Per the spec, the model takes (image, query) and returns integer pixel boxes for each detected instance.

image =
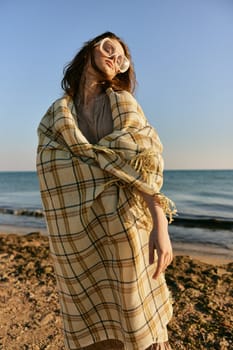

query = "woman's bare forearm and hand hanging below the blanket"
[138,192,173,279]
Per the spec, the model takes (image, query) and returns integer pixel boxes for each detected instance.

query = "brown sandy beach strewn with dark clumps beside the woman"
[0,226,233,350]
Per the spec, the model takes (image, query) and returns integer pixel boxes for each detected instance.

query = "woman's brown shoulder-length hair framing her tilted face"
[61,32,136,97]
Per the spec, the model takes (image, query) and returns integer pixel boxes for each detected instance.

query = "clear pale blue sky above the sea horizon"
[0,0,233,170]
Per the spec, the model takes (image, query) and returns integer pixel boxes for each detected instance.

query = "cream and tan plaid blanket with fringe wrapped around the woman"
[37,88,173,350]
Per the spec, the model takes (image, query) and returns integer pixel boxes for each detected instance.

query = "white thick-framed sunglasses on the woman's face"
[95,38,130,73]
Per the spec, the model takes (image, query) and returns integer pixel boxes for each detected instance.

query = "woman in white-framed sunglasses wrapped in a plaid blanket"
[37,32,175,350]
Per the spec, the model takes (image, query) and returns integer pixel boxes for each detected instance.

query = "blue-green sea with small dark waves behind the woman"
[0,170,233,251]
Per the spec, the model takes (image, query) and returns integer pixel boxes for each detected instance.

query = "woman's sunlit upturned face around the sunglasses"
[94,39,125,80]
